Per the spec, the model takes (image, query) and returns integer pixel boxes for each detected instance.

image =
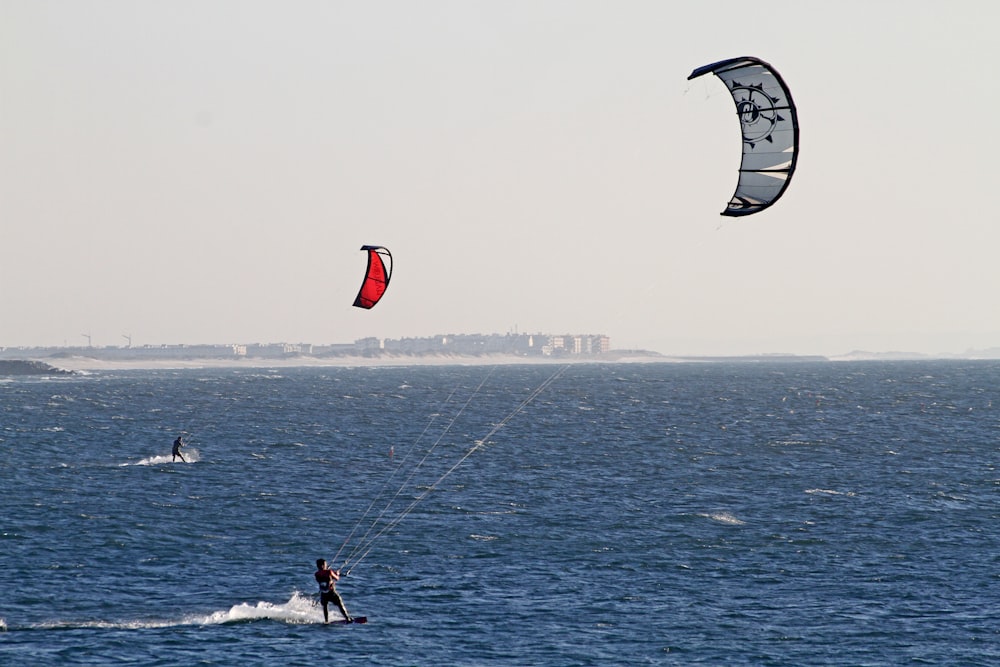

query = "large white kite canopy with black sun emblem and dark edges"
[688,57,799,216]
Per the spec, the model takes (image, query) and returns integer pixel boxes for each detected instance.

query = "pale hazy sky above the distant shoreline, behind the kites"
[0,0,1000,354]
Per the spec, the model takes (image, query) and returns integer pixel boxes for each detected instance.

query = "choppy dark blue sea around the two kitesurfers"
[0,360,1000,667]
